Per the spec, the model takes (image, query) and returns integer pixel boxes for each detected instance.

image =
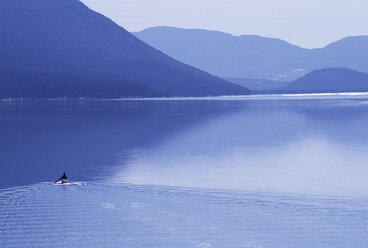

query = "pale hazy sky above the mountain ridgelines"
[82,0,368,48]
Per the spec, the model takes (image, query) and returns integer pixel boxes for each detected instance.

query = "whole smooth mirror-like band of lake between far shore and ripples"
[0,96,368,196]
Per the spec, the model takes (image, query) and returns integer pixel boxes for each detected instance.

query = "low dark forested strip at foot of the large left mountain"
[0,71,160,99]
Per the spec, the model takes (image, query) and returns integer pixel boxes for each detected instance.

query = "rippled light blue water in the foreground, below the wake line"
[0,183,368,248]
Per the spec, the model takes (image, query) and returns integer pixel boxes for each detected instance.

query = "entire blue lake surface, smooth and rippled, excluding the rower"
[0,95,368,247]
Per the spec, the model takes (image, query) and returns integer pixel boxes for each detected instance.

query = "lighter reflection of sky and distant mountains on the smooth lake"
[114,100,368,196]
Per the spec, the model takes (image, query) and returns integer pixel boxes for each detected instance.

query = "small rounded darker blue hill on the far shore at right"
[278,68,368,93]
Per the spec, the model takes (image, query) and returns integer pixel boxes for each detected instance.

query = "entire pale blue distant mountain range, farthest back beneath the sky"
[133,27,368,81]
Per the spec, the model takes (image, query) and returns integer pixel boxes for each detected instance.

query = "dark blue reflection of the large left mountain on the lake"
[0,101,244,188]
